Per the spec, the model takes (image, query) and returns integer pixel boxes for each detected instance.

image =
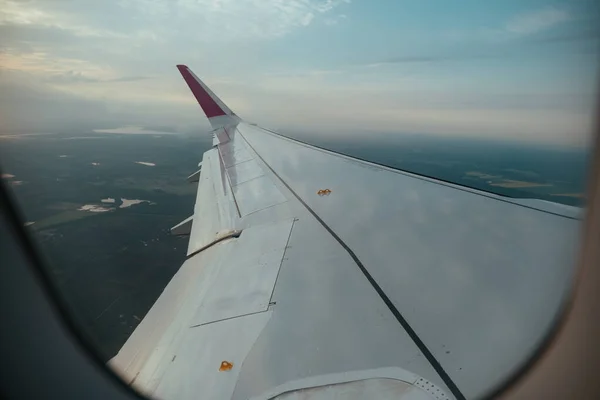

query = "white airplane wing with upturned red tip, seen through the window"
[110,65,580,400]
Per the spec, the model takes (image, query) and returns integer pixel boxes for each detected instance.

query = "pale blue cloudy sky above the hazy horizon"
[0,0,600,146]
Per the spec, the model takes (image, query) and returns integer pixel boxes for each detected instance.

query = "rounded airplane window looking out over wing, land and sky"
[0,0,600,400]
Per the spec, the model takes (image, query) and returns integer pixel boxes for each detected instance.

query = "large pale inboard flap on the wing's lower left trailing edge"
[110,220,293,398]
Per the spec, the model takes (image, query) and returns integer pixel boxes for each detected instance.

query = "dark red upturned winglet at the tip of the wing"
[177,64,239,128]
